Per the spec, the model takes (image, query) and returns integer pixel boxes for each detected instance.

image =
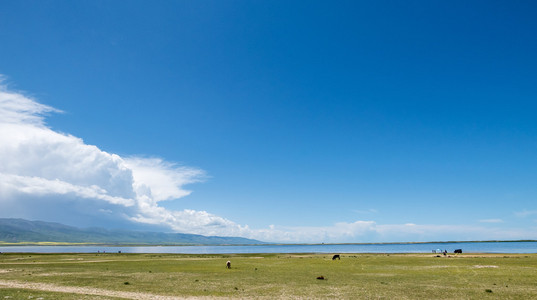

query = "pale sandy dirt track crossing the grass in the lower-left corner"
[0,280,220,300]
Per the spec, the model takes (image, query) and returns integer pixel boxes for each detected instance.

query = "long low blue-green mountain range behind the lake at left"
[0,218,264,245]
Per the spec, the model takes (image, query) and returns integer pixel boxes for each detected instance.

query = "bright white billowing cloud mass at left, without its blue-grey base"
[0,82,213,233]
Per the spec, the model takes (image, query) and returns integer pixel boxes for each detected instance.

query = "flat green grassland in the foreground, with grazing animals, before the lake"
[0,253,537,299]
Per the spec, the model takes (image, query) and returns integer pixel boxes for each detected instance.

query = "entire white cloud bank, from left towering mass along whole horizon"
[0,81,537,242]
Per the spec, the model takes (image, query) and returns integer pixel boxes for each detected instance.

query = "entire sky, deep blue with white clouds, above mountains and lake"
[0,0,537,242]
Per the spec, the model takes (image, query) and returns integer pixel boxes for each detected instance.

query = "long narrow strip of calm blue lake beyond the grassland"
[0,242,537,254]
